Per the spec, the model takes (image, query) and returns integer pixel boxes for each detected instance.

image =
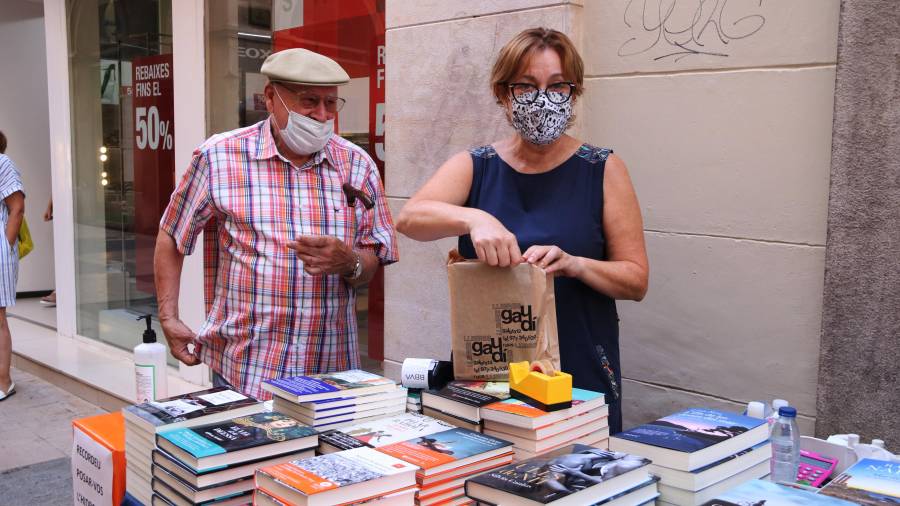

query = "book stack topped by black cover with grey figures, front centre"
[465,445,659,506]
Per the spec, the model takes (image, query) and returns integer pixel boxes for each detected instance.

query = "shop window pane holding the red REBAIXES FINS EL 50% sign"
[67,0,175,364]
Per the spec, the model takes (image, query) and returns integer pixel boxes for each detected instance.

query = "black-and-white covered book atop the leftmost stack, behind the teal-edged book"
[122,387,265,431]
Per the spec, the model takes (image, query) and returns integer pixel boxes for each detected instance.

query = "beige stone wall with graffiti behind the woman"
[385,0,840,433]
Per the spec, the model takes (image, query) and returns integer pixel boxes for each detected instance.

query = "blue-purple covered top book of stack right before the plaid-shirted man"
[262,369,397,403]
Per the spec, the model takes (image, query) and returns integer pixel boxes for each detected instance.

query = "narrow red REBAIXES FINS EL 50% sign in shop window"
[131,54,175,293]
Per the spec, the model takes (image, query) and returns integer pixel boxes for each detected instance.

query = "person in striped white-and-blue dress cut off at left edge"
[0,132,25,401]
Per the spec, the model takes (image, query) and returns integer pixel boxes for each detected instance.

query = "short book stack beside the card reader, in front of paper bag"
[422,381,509,432]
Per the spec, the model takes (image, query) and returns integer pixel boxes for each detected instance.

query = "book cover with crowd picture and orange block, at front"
[257,448,415,495]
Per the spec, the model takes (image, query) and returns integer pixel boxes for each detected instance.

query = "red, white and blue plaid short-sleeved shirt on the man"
[160,120,398,399]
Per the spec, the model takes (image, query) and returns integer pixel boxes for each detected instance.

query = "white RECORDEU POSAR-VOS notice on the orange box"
[72,428,113,506]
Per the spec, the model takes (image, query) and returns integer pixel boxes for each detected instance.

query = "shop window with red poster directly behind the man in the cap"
[206,0,384,370]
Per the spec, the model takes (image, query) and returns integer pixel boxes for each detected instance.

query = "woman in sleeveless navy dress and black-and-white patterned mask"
[397,28,649,433]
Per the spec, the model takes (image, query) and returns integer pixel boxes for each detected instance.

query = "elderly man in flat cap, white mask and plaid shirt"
[154,49,398,399]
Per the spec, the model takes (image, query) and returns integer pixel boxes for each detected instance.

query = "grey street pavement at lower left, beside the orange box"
[0,368,105,506]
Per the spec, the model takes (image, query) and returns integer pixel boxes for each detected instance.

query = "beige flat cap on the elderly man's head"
[260,48,350,86]
